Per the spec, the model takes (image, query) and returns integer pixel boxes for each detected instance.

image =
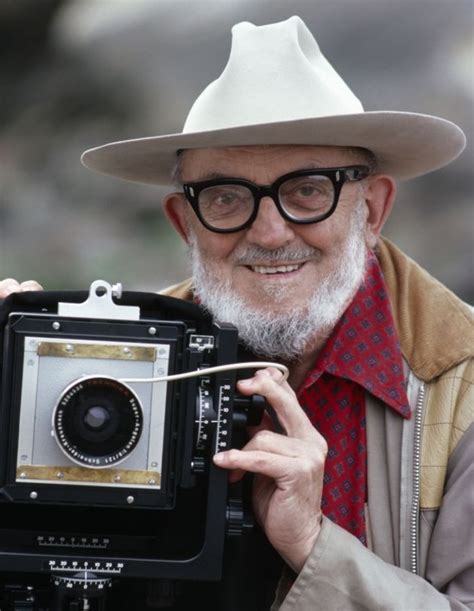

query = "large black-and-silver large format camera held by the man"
[0,281,274,611]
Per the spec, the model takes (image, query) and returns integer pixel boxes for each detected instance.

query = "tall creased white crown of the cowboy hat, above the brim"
[183,16,363,133]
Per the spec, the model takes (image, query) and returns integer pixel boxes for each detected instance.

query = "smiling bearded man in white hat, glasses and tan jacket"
[0,17,474,611]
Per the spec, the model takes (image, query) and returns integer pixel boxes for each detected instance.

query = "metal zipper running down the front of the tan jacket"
[410,383,425,575]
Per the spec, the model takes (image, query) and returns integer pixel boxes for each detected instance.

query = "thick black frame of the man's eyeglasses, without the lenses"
[182,165,370,233]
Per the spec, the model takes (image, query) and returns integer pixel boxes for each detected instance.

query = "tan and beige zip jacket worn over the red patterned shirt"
[161,240,474,611]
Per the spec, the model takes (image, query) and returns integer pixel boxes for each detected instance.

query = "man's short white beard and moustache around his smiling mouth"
[190,205,366,362]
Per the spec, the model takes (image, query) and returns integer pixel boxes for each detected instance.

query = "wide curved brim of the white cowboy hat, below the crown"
[81,111,466,185]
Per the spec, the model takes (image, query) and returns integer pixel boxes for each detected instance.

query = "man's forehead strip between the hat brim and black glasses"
[180,145,362,180]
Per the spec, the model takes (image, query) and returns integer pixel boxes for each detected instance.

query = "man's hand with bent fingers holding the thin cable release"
[214,368,327,572]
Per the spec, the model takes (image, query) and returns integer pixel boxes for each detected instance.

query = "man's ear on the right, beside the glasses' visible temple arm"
[364,174,397,248]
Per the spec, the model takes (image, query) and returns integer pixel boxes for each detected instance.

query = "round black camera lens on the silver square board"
[53,376,143,468]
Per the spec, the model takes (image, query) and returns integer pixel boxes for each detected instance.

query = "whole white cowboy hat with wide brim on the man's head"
[82,16,466,185]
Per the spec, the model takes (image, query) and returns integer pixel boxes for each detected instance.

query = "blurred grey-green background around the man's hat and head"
[0,0,474,303]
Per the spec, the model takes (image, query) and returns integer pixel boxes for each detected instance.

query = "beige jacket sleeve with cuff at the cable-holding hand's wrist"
[272,426,474,611]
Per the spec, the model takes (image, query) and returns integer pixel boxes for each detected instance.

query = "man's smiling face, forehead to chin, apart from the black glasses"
[178,146,370,312]
